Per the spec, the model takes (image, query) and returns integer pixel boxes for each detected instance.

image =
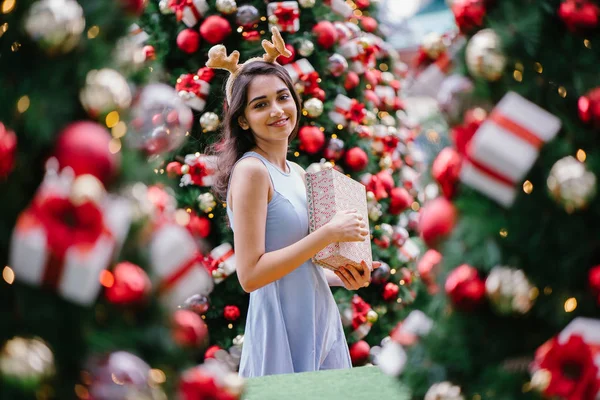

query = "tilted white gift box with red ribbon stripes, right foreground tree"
[460,92,561,207]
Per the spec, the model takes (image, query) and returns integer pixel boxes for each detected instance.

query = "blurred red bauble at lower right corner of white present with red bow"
[105,261,151,305]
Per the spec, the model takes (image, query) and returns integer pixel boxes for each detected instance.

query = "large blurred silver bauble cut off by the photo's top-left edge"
[25,0,85,54]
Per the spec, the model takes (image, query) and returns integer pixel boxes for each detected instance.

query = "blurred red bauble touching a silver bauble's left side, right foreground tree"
[445,264,485,311]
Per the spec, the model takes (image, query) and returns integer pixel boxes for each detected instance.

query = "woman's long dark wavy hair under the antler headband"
[207,61,302,201]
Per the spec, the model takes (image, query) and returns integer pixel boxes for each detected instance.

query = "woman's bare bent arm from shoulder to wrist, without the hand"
[230,157,335,293]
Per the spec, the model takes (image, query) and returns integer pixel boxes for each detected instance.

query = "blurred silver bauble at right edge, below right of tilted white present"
[547,156,596,212]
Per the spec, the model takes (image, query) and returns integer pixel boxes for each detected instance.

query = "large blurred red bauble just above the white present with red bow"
[53,121,121,186]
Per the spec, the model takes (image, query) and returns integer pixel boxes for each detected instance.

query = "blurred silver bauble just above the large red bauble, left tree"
[79,68,131,118]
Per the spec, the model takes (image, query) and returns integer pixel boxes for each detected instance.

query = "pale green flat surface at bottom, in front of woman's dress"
[242,367,410,400]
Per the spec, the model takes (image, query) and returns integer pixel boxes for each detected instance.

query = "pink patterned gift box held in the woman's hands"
[306,168,373,271]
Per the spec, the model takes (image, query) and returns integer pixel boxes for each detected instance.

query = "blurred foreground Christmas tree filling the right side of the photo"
[390,0,600,400]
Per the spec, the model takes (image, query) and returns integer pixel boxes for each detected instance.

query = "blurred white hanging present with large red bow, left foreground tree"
[9,158,131,306]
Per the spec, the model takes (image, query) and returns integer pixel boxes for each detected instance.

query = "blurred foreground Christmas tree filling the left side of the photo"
[0,0,242,400]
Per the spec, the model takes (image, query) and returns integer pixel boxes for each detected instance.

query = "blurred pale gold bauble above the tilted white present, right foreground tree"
[465,29,506,81]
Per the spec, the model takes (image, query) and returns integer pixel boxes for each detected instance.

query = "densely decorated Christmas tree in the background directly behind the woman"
[140,0,434,365]
